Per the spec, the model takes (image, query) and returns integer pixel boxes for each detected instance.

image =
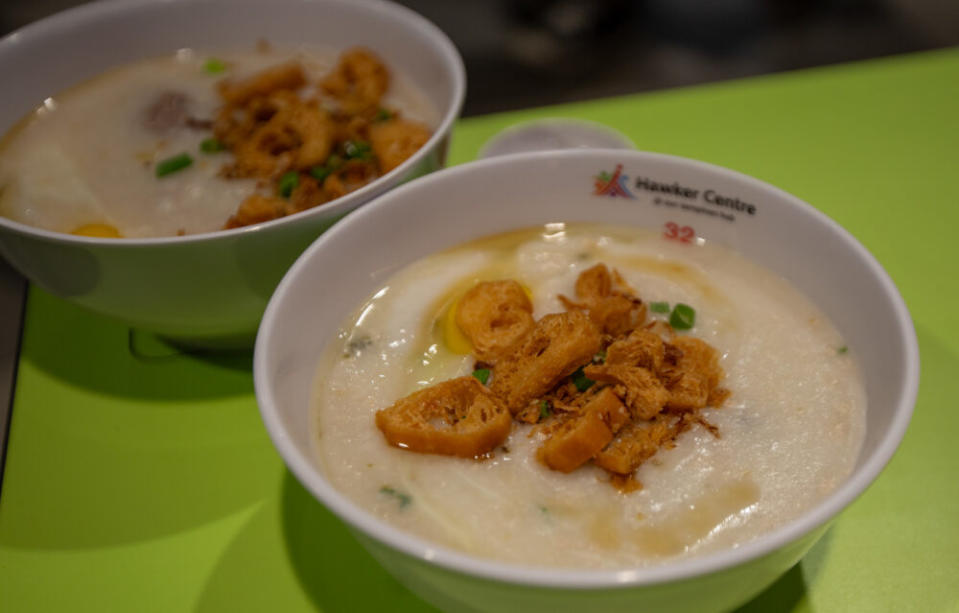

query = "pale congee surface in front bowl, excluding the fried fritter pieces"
[313,224,866,568]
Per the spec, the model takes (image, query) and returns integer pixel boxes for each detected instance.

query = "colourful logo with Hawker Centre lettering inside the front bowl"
[593,164,756,221]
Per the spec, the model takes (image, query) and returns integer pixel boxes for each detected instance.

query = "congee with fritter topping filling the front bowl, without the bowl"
[312,224,866,568]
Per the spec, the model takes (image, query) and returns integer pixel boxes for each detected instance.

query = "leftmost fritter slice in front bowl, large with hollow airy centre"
[376,376,513,458]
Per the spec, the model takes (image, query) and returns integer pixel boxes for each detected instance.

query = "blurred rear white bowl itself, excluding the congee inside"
[0,0,466,345]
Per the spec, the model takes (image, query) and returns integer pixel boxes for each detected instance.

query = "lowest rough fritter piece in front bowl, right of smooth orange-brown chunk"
[593,414,689,475]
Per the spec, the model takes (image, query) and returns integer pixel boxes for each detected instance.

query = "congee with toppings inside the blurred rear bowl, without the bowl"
[0,43,438,237]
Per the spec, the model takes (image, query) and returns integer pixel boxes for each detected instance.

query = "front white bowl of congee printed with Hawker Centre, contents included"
[254,150,919,612]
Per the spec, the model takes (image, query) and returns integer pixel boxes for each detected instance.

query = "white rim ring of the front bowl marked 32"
[253,149,919,590]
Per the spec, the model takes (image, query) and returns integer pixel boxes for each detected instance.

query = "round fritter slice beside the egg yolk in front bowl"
[456,280,536,364]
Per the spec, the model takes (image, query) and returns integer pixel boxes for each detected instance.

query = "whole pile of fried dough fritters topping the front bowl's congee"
[376,264,730,491]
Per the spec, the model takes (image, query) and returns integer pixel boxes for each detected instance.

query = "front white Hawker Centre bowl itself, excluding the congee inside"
[254,150,919,613]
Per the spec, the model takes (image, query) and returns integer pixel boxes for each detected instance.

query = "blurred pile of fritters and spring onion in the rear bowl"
[210,48,431,228]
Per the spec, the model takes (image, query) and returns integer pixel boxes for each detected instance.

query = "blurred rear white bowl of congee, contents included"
[0,0,465,346]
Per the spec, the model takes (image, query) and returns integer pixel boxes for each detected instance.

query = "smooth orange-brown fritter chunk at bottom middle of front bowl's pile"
[537,387,630,473]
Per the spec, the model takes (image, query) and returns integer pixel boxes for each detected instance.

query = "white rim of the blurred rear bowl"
[0,0,466,248]
